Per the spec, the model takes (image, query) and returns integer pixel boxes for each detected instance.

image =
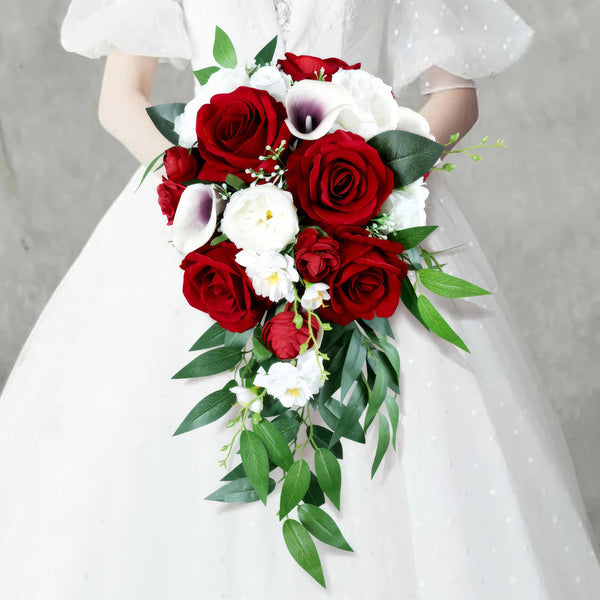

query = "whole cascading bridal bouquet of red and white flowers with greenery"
[146,28,501,586]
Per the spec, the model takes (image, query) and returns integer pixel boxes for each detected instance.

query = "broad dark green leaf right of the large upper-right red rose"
[368,130,444,187]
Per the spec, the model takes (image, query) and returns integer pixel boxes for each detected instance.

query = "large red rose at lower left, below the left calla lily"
[181,242,270,333]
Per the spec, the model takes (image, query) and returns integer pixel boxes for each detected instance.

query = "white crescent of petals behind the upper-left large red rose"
[174,66,250,148]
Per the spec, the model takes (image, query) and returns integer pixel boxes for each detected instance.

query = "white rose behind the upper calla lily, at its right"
[331,69,399,139]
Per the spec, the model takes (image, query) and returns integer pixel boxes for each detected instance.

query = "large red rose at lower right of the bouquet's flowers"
[319,227,408,325]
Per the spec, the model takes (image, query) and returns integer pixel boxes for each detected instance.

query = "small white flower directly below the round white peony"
[235,250,300,302]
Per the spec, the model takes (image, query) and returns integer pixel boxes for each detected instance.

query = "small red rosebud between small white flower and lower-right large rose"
[294,227,340,283]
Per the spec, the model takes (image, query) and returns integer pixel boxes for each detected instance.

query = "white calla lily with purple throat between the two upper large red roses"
[286,79,358,140]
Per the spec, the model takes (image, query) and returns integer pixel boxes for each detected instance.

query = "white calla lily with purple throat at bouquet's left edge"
[173,183,219,254]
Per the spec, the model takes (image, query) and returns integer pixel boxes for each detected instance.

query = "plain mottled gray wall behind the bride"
[0,0,600,532]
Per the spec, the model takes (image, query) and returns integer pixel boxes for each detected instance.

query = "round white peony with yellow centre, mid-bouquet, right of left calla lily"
[221,183,299,252]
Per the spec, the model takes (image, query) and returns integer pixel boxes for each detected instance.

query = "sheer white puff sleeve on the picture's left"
[61,0,191,68]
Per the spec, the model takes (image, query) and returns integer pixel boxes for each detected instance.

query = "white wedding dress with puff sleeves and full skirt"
[0,0,600,600]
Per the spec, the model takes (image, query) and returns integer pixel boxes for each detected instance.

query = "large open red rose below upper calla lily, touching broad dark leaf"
[287,131,394,226]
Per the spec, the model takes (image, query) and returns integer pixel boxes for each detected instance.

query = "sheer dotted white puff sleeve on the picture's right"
[388,0,533,93]
